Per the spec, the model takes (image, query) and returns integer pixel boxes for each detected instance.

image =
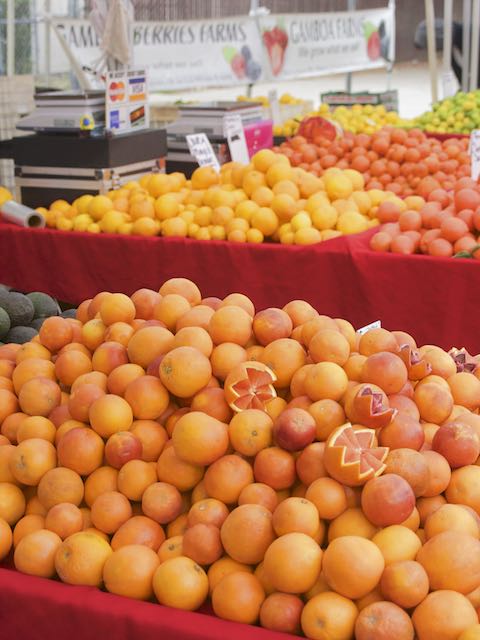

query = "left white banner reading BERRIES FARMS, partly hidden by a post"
[51,16,265,90]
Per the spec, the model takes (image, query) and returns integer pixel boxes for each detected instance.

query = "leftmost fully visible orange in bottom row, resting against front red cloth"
[13,529,62,578]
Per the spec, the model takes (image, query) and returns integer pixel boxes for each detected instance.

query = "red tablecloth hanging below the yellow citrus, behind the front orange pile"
[0,224,480,353]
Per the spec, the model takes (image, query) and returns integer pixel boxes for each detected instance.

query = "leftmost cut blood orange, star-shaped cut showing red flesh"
[223,361,277,411]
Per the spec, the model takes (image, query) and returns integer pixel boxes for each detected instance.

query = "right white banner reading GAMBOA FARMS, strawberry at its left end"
[260,9,395,79]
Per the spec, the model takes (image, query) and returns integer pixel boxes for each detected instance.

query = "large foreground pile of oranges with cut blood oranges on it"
[0,278,480,640]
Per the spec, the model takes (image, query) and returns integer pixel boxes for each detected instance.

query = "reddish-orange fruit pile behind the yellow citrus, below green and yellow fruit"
[275,127,470,197]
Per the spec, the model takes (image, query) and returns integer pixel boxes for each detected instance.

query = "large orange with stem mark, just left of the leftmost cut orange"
[160,347,212,398]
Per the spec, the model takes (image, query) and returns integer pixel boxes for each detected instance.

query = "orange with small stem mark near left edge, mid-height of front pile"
[9,440,57,486]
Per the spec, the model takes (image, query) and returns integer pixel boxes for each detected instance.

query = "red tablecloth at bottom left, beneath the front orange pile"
[0,568,298,640]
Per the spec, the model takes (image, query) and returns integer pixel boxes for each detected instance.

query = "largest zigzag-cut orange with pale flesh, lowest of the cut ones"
[323,422,389,487]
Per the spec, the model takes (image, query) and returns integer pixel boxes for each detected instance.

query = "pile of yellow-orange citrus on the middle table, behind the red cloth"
[38,149,407,245]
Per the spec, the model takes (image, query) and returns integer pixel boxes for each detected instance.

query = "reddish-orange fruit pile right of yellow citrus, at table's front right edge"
[370,177,480,260]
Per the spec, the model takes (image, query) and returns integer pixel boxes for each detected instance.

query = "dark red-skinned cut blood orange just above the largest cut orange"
[345,384,397,429]
